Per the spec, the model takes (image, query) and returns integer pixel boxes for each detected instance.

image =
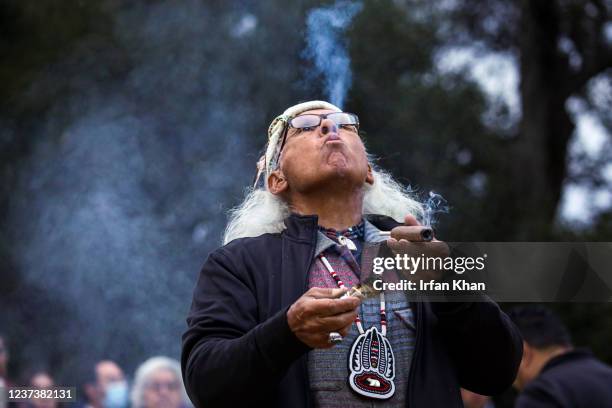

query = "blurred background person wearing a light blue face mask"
[83,360,129,408]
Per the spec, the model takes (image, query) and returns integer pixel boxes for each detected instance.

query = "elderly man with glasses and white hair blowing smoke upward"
[182,101,522,408]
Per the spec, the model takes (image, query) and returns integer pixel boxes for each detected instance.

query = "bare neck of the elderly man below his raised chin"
[291,190,363,230]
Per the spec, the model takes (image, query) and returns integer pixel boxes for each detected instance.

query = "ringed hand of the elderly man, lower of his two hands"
[287,288,361,348]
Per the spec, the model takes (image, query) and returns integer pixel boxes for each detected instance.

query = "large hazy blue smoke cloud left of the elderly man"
[0,0,301,384]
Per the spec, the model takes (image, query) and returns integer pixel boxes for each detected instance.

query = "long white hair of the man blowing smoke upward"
[223,160,424,244]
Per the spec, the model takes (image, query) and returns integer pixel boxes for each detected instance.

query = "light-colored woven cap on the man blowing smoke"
[253,101,342,189]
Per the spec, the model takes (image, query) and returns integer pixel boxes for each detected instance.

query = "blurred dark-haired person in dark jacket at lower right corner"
[509,305,612,408]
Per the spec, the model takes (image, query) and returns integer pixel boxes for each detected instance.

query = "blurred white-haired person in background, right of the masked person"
[131,357,191,408]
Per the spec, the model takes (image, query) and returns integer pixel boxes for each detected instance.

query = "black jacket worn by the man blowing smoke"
[181,214,522,408]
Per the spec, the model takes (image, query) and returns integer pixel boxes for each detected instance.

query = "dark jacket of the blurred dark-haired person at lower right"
[515,350,612,408]
